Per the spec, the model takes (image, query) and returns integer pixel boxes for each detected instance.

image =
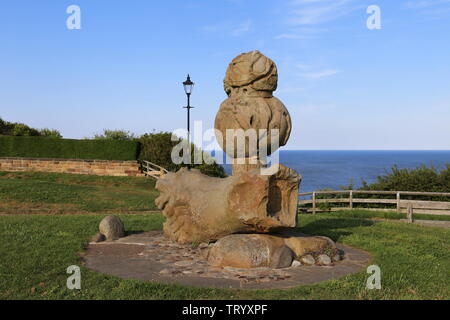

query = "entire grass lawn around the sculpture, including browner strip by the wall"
[0,172,450,299]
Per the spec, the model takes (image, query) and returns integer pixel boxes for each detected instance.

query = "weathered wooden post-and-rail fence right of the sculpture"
[298,190,450,215]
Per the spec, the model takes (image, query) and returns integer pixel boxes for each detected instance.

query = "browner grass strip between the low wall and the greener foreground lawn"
[0,172,158,214]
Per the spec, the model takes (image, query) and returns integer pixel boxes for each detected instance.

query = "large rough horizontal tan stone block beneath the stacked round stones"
[155,165,301,243]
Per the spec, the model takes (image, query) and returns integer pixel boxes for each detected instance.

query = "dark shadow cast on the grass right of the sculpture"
[297,218,376,241]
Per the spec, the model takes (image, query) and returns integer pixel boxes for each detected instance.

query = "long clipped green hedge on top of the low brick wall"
[0,136,140,160]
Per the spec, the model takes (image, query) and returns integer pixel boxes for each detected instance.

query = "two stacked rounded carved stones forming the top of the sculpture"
[215,51,292,158]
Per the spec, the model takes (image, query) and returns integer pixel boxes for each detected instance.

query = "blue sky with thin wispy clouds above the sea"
[0,0,450,150]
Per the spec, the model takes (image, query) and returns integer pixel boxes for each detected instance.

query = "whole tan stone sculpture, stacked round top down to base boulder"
[156,51,336,268]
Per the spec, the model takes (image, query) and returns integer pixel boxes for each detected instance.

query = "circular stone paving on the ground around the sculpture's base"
[84,231,370,289]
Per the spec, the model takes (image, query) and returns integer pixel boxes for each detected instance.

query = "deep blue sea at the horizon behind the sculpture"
[223,150,450,192]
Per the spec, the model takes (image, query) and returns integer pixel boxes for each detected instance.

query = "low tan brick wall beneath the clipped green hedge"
[0,158,143,177]
